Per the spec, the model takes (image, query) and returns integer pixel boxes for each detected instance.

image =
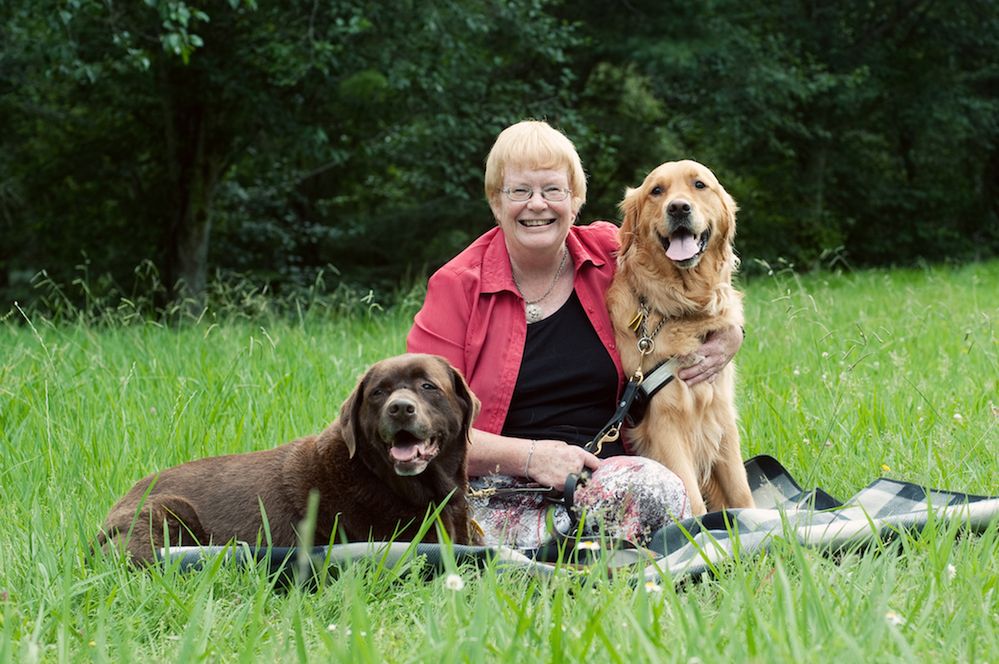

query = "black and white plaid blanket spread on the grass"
[161,455,999,580]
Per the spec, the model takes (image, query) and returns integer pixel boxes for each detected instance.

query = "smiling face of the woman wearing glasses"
[490,168,576,259]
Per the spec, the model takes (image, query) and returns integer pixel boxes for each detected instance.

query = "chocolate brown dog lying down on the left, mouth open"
[98,355,479,562]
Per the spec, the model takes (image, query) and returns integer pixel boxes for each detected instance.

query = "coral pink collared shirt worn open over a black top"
[406,221,624,434]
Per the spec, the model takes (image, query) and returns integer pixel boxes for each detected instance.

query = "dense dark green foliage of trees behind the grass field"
[0,0,999,306]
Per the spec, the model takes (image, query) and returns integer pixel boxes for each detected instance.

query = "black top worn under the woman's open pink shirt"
[503,291,624,456]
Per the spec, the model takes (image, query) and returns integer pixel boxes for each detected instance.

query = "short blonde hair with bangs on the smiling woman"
[485,120,586,212]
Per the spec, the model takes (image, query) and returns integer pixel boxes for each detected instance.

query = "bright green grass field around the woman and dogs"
[0,262,999,662]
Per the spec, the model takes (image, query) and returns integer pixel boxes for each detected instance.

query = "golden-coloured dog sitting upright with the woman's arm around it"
[607,161,753,515]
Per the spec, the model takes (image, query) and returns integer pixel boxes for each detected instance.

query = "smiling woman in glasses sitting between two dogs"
[407,121,742,547]
